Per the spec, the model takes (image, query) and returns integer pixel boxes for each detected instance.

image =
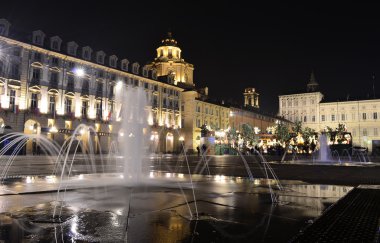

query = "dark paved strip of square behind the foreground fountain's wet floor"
[0,155,380,186]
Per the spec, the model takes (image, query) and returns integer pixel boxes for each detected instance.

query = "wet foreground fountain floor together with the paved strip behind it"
[0,156,380,243]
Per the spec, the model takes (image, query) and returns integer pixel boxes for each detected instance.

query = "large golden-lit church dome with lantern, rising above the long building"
[147,32,194,86]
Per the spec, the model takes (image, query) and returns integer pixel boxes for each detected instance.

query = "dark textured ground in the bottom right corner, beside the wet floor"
[291,186,380,243]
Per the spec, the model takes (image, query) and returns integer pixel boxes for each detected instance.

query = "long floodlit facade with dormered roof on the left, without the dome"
[0,19,183,153]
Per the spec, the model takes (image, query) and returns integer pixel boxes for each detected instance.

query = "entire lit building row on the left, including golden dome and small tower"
[0,19,286,154]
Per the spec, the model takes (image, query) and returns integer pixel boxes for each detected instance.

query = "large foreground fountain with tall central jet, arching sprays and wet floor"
[0,88,356,242]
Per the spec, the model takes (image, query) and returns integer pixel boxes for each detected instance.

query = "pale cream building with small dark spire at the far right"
[278,74,380,151]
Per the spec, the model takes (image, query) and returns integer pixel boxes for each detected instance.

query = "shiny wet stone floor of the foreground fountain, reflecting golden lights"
[0,172,352,242]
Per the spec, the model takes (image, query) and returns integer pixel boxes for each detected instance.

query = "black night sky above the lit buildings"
[0,0,380,113]
